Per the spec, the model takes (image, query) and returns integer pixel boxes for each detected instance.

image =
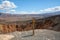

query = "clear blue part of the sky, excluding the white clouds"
[0,0,60,14]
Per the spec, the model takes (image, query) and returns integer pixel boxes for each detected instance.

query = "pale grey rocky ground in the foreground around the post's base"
[0,29,60,40]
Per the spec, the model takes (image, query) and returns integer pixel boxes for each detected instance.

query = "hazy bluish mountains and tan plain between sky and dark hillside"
[0,11,60,22]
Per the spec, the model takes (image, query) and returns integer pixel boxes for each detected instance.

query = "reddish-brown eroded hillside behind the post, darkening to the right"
[0,15,60,33]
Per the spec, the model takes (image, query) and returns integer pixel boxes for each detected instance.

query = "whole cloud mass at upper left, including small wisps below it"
[0,0,17,13]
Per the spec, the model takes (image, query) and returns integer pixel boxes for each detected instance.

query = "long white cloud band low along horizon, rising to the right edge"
[16,6,60,14]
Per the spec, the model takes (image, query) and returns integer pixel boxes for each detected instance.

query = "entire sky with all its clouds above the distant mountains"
[0,0,60,14]
